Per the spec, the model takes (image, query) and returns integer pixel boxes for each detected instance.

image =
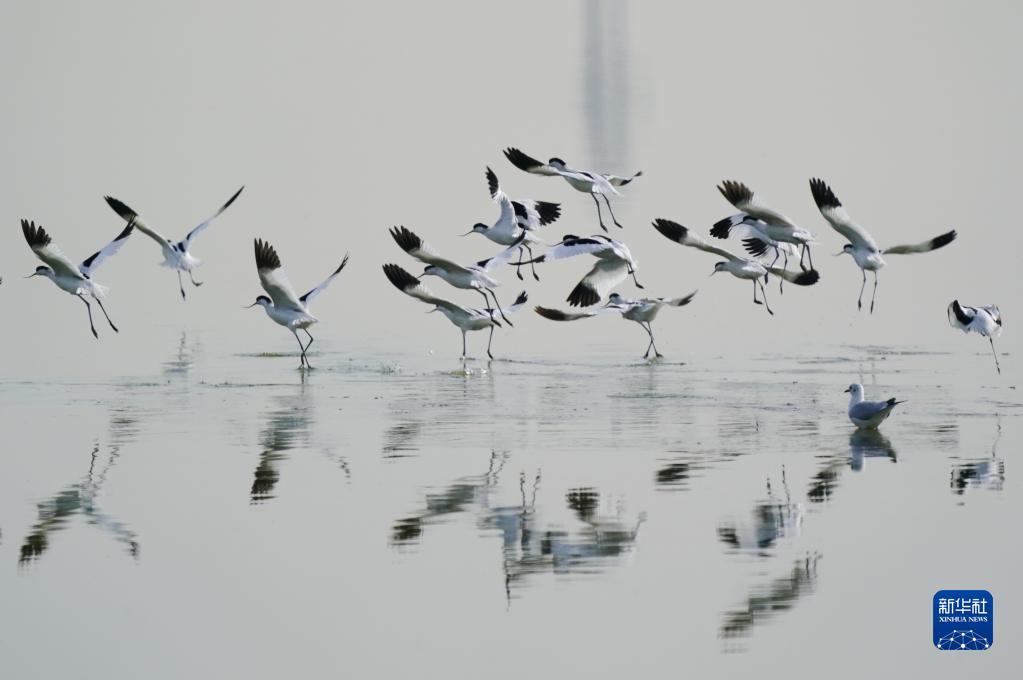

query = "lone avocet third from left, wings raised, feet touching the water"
[246,238,348,368]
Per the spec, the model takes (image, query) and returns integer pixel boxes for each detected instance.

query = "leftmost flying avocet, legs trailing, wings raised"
[21,220,135,339]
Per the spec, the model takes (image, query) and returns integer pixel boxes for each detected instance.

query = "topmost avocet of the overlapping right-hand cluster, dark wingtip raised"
[711,180,813,271]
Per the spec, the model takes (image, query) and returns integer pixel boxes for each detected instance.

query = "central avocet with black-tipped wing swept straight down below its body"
[530,234,642,307]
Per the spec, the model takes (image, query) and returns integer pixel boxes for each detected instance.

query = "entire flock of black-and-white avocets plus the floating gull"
[9,148,1002,426]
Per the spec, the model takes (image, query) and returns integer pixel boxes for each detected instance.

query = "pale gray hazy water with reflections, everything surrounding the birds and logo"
[0,2,1023,678]
